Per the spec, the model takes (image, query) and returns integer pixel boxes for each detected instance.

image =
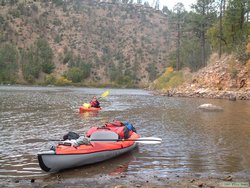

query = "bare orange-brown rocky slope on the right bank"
[168,55,250,100]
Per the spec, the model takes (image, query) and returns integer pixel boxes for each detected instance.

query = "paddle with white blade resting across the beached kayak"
[23,137,162,144]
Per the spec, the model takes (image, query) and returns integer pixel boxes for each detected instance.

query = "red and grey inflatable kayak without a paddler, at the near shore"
[38,131,139,172]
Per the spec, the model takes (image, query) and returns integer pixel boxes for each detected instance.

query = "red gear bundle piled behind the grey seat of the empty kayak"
[86,121,133,139]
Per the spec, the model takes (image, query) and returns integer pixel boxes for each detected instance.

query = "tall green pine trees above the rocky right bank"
[162,0,250,71]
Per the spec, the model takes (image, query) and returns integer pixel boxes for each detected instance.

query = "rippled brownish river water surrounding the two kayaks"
[0,86,250,178]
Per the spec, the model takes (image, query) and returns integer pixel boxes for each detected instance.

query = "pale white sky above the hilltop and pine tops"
[147,0,197,10]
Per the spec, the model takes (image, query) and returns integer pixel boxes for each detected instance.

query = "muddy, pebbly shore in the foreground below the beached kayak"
[0,173,250,188]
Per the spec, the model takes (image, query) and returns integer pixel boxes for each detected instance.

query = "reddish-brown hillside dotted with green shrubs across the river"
[0,0,174,86]
